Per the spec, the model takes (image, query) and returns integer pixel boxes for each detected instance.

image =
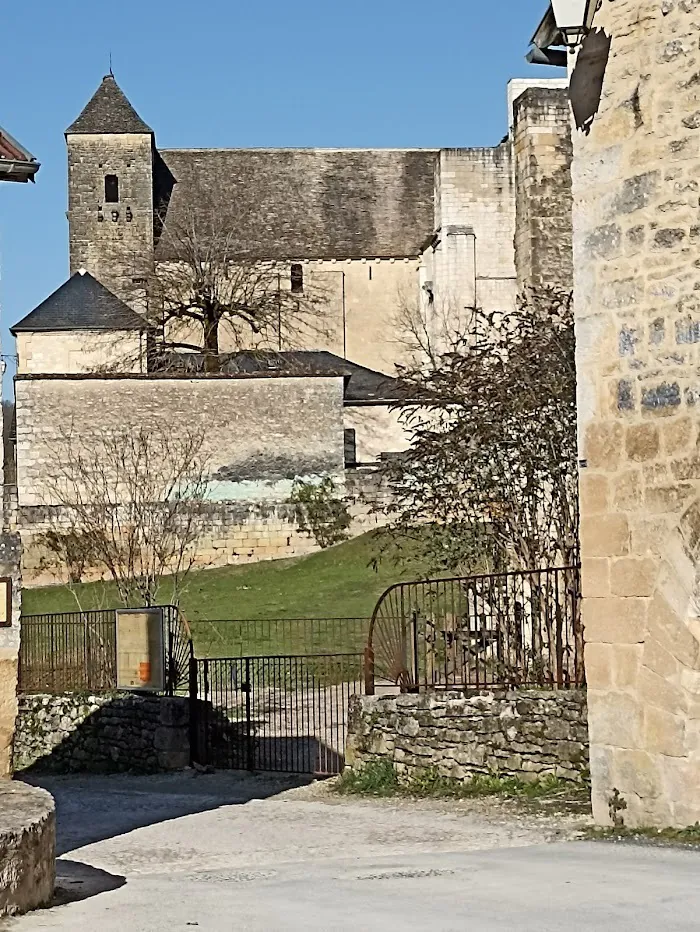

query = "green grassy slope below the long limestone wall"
[22,532,421,620]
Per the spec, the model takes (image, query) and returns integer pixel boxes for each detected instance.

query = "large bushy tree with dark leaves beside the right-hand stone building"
[386,292,578,572]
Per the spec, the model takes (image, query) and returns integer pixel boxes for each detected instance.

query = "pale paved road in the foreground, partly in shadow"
[8,775,700,932]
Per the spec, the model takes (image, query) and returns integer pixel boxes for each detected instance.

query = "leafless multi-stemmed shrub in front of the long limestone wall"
[37,427,209,606]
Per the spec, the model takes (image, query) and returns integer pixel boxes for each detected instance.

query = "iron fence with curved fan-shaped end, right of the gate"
[365,567,585,693]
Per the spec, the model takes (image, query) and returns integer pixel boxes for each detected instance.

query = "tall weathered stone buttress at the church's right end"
[513,88,573,292]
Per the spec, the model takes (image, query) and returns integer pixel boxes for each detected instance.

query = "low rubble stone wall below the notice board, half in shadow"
[13,693,190,773]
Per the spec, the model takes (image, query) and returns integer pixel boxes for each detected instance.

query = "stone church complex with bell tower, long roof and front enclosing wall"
[12,74,572,582]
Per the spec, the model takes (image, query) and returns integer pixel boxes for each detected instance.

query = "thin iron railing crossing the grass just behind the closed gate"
[189,618,370,658]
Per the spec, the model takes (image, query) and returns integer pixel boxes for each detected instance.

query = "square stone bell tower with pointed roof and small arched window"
[66,72,155,312]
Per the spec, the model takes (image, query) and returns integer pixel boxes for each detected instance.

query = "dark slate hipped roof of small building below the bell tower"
[10,270,148,334]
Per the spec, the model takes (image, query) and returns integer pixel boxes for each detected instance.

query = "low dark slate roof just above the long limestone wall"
[156,350,401,404]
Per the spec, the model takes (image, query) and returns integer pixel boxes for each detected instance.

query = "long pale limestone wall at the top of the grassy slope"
[13,376,356,584]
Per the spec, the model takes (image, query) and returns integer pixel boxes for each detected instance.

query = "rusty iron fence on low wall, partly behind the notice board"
[19,605,190,695]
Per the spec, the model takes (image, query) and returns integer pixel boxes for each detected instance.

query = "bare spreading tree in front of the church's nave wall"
[149,208,328,372]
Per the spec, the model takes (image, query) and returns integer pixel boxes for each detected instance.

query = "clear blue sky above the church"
[0,0,560,386]
